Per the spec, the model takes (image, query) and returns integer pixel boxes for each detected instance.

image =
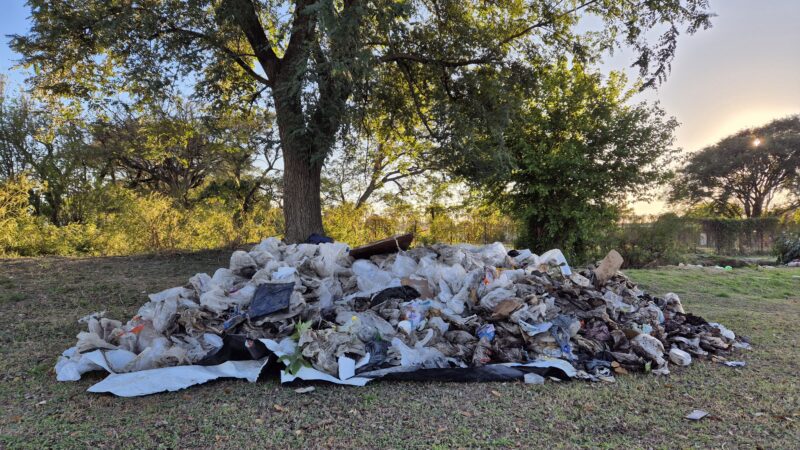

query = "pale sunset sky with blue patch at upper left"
[0,0,800,214]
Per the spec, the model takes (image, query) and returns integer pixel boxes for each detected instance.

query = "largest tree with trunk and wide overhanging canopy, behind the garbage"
[12,0,710,241]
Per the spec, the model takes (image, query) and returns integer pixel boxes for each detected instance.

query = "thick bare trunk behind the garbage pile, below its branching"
[283,148,323,242]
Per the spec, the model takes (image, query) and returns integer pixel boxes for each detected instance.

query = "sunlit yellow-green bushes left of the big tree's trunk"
[0,181,282,256]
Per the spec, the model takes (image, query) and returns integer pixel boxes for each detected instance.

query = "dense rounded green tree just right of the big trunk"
[460,61,677,259]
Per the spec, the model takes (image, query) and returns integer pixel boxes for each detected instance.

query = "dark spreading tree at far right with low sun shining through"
[670,116,800,218]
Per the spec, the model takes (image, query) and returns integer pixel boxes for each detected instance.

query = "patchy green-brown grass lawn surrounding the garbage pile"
[0,252,800,449]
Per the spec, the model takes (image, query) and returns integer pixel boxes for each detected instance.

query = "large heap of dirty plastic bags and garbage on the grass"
[56,236,749,395]
